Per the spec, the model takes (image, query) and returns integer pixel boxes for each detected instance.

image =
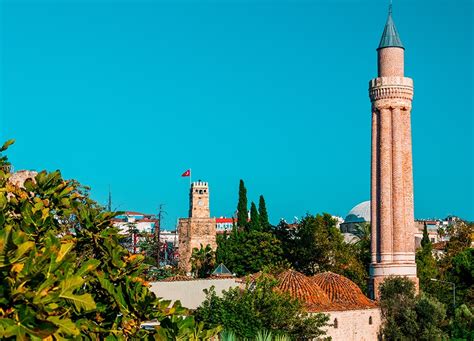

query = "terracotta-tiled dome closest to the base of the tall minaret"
[311,272,377,310]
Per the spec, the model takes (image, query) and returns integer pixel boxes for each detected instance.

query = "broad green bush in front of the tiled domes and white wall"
[196,275,329,339]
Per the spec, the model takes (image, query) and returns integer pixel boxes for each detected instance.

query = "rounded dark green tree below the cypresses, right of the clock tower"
[216,230,284,276]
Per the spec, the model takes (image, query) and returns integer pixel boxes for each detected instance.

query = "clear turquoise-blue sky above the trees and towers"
[0,0,474,228]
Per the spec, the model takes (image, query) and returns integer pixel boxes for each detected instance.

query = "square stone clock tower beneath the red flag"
[178,181,217,273]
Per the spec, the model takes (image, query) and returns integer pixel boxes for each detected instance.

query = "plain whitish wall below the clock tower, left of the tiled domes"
[150,278,239,309]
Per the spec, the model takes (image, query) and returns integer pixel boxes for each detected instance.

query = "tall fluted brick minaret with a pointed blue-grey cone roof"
[369,4,418,298]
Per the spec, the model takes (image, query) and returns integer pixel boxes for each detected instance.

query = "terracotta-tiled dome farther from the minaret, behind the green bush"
[276,270,330,310]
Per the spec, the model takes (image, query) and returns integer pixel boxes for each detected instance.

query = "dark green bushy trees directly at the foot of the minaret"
[380,277,446,340]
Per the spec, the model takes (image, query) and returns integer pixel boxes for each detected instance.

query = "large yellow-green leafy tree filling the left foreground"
[0,142,220,340]
